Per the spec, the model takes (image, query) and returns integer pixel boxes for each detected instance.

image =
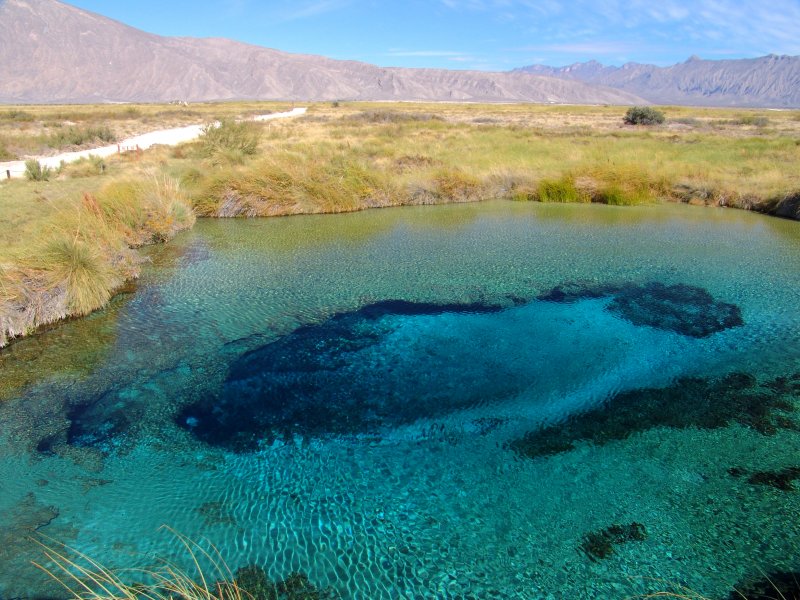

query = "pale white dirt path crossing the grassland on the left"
[0,108,307,178]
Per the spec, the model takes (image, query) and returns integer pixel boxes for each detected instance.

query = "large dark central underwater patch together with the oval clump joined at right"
[176,283,742,451]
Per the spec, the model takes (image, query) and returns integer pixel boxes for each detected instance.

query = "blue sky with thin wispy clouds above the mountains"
[69,0,800,70]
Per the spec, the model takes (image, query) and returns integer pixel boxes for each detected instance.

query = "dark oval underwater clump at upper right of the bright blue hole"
[538,282,744,338]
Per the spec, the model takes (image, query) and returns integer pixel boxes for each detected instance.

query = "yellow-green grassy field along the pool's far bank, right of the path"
[179,105,800,216]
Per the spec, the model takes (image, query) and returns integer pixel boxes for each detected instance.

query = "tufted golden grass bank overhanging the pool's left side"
[0,169,194,346]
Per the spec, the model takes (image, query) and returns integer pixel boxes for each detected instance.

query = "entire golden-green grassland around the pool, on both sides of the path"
[0,103,800,345]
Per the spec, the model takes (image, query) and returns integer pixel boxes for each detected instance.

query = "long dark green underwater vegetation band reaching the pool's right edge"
[509,373,800,458]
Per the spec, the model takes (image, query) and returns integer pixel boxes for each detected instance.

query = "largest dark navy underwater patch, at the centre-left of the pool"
[176,300,505,451]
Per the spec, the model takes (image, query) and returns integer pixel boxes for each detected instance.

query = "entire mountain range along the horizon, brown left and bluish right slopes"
[0,0,800,107]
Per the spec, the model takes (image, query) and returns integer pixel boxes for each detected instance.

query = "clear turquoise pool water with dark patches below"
[0,202,800,599]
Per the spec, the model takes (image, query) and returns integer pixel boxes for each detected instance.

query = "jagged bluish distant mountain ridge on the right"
[513,54,800,108]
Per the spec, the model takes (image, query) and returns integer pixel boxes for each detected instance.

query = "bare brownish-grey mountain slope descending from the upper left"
[0,0,644,104]
